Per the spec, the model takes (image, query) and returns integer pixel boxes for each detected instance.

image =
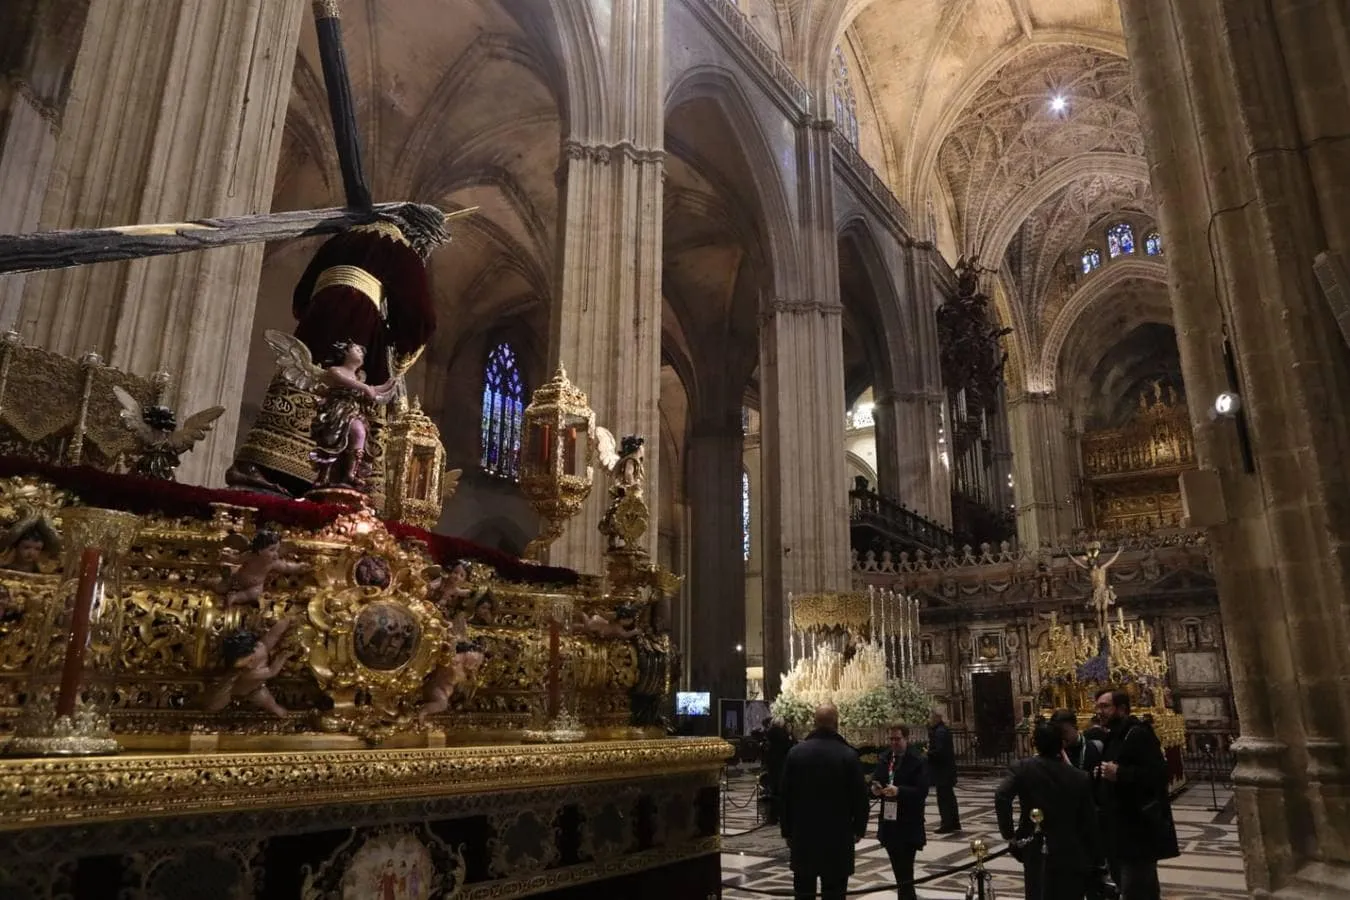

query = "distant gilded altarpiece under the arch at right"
[1081,386,1195,533]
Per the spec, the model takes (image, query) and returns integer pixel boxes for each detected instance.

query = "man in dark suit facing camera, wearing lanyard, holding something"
[872,725,929,900]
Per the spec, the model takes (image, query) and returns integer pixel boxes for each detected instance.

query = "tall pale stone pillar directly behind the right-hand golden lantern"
[549,0,666,572]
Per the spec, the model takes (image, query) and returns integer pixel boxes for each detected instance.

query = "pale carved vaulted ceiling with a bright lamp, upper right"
[784,0,1153,391]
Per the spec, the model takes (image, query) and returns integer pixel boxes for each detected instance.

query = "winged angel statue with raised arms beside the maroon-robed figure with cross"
[265,331,398,493]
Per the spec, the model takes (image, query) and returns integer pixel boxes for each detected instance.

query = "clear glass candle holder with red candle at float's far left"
[4,506,140,756]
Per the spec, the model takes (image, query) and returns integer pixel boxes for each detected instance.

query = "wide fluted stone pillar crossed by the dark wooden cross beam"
[0,0,306,483]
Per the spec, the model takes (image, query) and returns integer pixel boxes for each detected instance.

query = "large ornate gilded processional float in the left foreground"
[0,336,728,897]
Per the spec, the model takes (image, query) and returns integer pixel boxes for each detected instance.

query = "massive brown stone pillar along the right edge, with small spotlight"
[1121,0,1350,897]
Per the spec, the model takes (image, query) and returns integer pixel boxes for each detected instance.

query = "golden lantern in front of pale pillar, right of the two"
[520,366,595,560]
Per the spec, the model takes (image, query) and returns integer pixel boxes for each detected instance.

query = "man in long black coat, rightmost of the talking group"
[1096,691,1181,900]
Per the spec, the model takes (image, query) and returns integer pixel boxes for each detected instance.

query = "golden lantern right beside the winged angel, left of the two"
[385,397,448,530]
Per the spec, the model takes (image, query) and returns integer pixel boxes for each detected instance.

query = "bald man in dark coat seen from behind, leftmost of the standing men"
[779,703,867,900]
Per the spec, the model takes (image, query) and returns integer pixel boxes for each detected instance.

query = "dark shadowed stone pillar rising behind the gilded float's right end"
[686,409,747,711]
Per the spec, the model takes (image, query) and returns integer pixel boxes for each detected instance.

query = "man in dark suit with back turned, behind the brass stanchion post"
[994,722,1102,900]
